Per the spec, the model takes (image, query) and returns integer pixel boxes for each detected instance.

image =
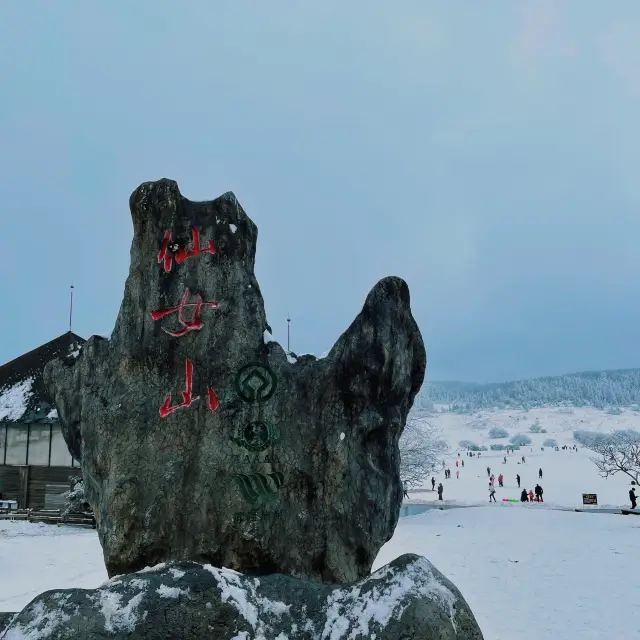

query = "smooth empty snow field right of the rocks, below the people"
[374,504,640,640]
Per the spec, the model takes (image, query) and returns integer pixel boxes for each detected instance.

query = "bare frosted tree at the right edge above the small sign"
[583,431,640,484]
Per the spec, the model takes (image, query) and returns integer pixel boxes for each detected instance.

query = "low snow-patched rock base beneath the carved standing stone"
[2,554,482,640]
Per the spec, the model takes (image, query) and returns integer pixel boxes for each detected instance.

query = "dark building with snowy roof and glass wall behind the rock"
[0,332,85,509]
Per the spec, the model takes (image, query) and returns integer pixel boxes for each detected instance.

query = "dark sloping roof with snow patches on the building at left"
[0,331,85,422]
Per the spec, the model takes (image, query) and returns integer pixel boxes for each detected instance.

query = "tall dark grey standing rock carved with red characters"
[45,180,426,583]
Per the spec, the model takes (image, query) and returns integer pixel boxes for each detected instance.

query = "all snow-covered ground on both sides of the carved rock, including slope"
[0,409,640,640]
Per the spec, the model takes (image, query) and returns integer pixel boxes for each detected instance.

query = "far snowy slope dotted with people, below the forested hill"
[408,409,640,508]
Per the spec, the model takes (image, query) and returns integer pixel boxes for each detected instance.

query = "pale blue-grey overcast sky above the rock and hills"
[0,0,640,381]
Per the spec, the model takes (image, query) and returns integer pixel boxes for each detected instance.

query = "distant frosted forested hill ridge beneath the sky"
[415,369,640,413]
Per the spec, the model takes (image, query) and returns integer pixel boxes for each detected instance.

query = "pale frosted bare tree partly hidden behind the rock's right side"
[400,418,449,488]
